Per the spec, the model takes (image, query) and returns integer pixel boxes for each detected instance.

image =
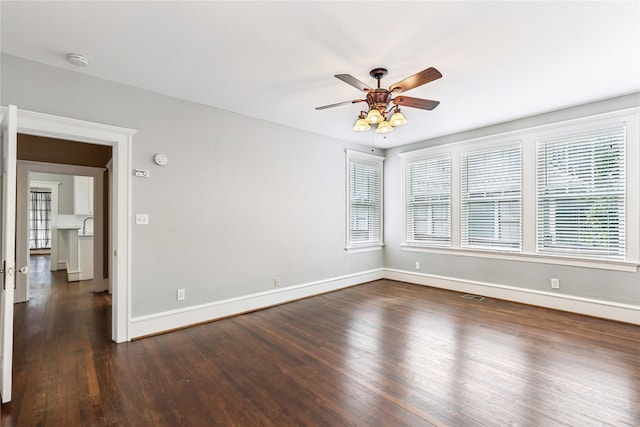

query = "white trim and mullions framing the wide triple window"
[399,107,640,272]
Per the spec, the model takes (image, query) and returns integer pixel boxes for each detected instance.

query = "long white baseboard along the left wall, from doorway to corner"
[129,268,384,338]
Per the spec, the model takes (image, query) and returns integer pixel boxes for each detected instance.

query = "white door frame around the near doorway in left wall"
[8,107,136,343]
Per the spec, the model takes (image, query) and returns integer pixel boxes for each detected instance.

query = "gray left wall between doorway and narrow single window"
[0,55,383,317]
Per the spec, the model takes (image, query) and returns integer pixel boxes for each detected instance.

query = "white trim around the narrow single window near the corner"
[345,150,385,253]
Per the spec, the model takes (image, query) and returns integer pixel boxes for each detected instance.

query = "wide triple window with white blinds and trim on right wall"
[400,108,640,271]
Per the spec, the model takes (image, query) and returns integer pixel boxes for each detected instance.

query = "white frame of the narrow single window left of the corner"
[345,150,385,253]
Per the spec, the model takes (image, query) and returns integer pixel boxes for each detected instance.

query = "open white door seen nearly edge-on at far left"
[0,105,18,403]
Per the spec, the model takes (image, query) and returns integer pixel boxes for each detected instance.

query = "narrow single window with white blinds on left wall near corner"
[346,150,384,250]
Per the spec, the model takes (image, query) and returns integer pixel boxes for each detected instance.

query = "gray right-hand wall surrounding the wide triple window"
[384,93,640,305]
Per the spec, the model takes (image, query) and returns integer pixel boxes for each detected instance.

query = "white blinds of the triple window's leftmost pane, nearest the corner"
[405,156,451,246]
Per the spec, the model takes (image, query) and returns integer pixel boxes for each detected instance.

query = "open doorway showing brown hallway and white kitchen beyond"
[16,134,112,308]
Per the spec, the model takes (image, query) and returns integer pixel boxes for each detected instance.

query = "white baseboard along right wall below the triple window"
[384,268,640,325]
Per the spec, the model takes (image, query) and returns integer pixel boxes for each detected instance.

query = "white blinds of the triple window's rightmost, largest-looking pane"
[537,124,626,259]
